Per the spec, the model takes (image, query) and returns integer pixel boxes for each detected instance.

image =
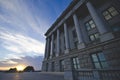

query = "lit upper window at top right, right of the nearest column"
[102,6,119,20]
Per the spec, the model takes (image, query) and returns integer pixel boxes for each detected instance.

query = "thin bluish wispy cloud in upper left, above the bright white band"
[0,0,49,36]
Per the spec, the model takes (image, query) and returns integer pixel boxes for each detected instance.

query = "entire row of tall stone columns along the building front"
[45,1,113,57]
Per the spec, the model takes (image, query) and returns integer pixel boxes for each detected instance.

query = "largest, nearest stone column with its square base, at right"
[86,1,114,41]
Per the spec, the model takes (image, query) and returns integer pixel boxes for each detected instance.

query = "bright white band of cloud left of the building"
[0,31,44,56]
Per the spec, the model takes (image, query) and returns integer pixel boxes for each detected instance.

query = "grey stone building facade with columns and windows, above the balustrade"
[42,0,120,75]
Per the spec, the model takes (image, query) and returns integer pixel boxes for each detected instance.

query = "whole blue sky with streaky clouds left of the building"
[0,0,72,70]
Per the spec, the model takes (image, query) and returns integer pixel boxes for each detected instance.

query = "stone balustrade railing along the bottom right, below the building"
[76,69,120,80]
